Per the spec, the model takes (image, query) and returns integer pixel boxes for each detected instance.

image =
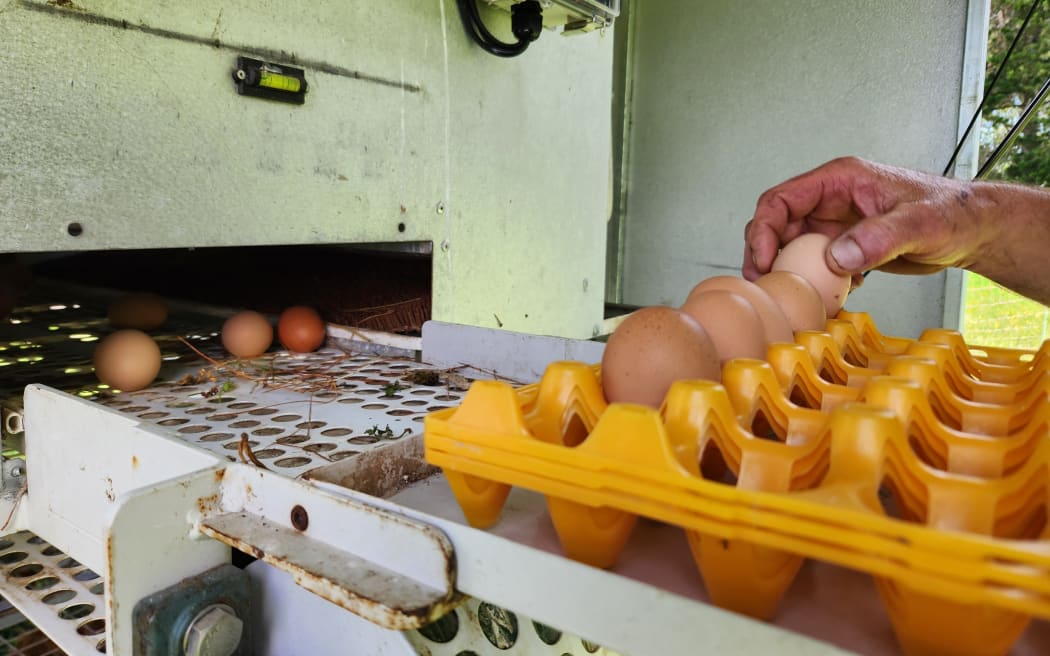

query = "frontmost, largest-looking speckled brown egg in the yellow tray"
[602,306,720,407]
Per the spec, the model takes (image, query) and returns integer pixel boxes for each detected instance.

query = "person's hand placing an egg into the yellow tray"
[742,157,991,287]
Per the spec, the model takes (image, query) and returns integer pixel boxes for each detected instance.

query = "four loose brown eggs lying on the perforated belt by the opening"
[92,294,326,392]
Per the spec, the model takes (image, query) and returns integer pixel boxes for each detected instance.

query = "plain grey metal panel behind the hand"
[623,0,980,336]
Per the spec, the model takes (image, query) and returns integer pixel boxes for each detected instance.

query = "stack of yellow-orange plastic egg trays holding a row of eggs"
[424,312,1050,654]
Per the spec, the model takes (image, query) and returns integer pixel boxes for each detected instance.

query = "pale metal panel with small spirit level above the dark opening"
[0,0,612,337]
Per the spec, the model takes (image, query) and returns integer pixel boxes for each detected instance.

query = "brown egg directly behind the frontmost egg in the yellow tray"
[681,290,768,364]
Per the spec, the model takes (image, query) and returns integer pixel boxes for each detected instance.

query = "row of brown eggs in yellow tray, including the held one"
[602,233,851,407]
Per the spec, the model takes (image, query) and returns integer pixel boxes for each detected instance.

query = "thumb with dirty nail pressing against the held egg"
[824,208,921,274]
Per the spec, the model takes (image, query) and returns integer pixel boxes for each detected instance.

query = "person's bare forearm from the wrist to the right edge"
[962,183,1050,304]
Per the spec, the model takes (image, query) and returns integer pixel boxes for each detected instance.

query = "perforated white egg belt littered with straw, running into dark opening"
[0,282,463,478]
